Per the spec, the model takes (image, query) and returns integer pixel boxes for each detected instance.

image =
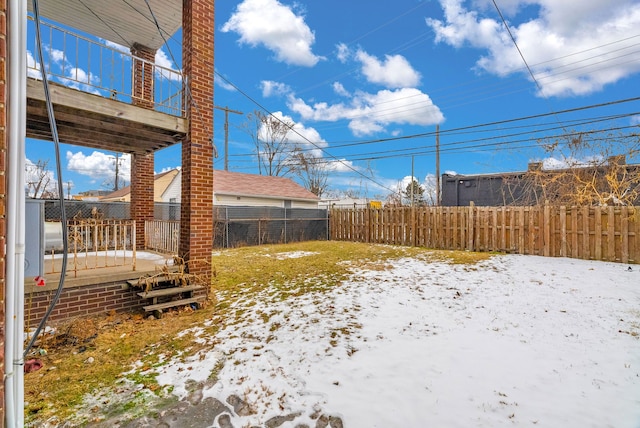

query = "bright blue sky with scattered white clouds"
[26,0,640,198]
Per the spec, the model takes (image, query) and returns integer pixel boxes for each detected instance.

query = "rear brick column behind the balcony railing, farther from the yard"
[131,44,156,249]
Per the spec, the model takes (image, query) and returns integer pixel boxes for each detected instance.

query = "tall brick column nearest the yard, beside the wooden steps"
[180,0,215,282]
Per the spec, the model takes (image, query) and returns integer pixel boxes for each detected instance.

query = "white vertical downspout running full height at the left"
[5,0,27,428]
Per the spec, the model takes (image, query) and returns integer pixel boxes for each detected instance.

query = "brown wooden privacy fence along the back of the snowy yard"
[330,205,640,263]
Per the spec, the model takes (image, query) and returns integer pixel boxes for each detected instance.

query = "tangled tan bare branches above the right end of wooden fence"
[502,133,640,205]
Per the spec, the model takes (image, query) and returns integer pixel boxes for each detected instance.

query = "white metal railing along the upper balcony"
[27,16,184,117]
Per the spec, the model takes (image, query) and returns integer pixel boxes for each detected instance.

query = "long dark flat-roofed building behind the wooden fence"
[441,160,640,206]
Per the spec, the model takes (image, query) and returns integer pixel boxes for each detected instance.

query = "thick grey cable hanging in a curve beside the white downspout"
[23,0,69,357]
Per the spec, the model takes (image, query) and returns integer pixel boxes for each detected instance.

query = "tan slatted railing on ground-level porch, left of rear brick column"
[45,219,136,277]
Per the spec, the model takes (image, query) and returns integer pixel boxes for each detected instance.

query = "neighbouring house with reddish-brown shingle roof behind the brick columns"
[102,169,319,209]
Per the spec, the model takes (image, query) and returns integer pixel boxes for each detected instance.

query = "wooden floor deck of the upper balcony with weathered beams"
[27,79,186,153]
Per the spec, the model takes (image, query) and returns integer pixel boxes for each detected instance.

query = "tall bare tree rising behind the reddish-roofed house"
[244,111,297,176]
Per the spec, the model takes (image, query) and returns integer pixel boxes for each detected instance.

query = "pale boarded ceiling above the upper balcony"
[27,0,182,49]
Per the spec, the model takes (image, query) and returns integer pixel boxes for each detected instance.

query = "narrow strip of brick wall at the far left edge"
[0,0,8,427]
